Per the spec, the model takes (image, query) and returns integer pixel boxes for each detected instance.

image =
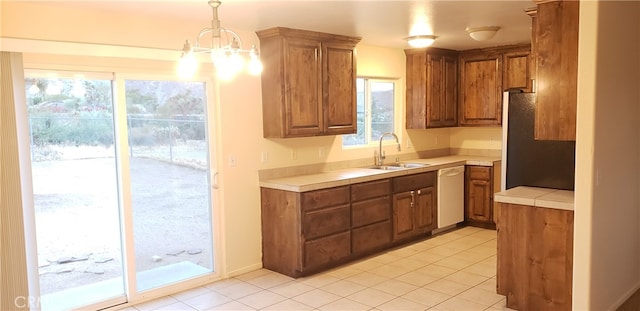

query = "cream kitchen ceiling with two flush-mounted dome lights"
[28,0,535,50]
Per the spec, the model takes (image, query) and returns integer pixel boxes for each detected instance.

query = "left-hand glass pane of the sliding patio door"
[26,77,125,310]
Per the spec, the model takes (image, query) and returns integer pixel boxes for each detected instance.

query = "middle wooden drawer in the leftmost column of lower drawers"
[302,205,351,240]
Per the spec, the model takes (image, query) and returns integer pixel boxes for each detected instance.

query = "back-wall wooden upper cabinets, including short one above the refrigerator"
[458,44,532,126]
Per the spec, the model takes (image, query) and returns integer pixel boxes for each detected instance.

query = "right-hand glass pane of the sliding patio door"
[125,80,213,291]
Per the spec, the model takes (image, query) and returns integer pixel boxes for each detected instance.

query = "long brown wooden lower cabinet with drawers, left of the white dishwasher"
[260,172,437,277]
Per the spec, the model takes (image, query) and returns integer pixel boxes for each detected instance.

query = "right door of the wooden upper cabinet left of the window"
[322,42,357,135]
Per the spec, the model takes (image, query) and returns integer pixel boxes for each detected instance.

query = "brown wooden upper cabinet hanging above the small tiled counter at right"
[530,1,580,140]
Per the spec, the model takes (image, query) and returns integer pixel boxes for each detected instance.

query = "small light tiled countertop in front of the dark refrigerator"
[494,186,574,211]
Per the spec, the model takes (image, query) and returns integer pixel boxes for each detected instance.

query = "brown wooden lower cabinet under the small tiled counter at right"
[495,203,573,310]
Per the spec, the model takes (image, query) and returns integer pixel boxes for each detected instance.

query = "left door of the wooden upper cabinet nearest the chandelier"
[284,38,325,136]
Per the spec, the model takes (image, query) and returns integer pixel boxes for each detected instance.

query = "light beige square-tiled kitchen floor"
[124,227,511,311]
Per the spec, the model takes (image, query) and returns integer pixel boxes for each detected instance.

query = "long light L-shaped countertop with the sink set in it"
[260,155,500,192]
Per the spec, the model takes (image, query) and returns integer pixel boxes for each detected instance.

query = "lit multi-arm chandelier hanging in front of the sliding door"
[178,0,262,80]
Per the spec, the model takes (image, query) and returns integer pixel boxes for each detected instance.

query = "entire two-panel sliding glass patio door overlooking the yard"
[25,72,214,310]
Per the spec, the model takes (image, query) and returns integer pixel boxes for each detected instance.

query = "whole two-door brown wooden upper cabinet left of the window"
[256,27,361,138]
